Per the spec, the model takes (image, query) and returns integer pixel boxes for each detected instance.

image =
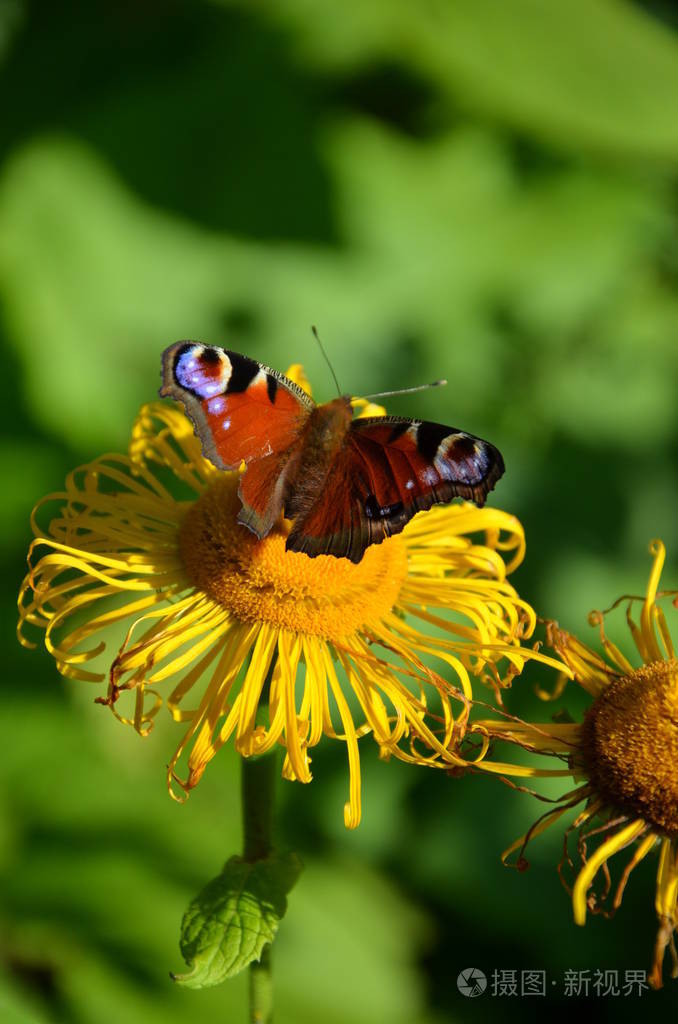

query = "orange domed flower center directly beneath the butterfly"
[179,473,408,640]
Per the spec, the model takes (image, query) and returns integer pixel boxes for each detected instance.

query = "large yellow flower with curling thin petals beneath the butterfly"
[19,368,535,828]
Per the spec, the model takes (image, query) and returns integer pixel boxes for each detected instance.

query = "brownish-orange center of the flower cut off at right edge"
[582,658,678,837]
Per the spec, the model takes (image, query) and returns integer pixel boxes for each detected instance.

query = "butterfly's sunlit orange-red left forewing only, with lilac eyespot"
[160,341,314,469]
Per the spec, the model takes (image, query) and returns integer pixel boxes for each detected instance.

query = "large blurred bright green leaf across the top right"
[258,0,678,162]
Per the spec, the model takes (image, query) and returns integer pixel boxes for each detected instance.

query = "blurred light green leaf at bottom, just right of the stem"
[273,856,433,1024]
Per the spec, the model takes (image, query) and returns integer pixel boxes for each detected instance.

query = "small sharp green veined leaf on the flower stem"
[171,853,301,988]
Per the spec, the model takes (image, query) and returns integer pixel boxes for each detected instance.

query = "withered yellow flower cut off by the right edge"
[472,541,678,988]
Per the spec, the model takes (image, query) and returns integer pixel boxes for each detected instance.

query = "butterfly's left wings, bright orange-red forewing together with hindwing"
[160,341,315,537]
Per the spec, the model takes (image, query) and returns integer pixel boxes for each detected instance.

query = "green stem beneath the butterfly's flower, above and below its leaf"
[242,754,278,1024]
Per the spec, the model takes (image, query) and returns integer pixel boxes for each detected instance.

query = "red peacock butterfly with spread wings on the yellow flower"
[160,341,504,562]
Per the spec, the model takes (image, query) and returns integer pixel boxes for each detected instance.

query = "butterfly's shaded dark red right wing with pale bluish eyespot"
[287,417,504,562]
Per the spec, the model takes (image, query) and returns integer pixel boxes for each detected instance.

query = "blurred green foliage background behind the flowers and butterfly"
[0,0,678,1024]
